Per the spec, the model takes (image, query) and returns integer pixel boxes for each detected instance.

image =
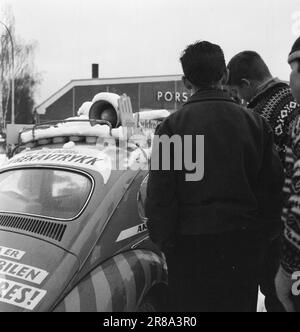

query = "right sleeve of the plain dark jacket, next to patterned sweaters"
[258,120,284,237]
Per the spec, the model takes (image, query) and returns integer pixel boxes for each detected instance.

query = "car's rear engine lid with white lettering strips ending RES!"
[0,230,79,312]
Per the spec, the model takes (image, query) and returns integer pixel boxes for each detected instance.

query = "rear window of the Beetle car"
[0,168,93,220]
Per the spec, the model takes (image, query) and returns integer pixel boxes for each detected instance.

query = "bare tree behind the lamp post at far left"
[0,6,41,128]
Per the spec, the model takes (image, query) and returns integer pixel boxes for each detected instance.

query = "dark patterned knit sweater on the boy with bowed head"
[248,78,299,164]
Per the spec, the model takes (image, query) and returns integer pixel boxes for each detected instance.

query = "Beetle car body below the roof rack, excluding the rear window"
[0,147,167,312]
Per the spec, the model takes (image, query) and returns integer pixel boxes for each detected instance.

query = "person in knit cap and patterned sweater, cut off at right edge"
[275,38,300,312]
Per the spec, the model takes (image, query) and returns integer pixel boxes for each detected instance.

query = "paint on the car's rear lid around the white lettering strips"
[0,230,79,312]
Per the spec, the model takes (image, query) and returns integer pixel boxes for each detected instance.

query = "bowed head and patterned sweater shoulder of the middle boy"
[227,51,299,164]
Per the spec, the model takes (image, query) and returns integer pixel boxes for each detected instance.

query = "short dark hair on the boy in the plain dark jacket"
[180,41,226,87]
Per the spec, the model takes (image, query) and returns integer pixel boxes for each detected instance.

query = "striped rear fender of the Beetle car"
[55,250,167,312]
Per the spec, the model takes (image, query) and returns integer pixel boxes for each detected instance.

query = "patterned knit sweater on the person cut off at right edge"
[281,116,300,274]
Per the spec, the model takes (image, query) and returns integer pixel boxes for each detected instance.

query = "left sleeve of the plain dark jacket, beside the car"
[146,119,178,251]
